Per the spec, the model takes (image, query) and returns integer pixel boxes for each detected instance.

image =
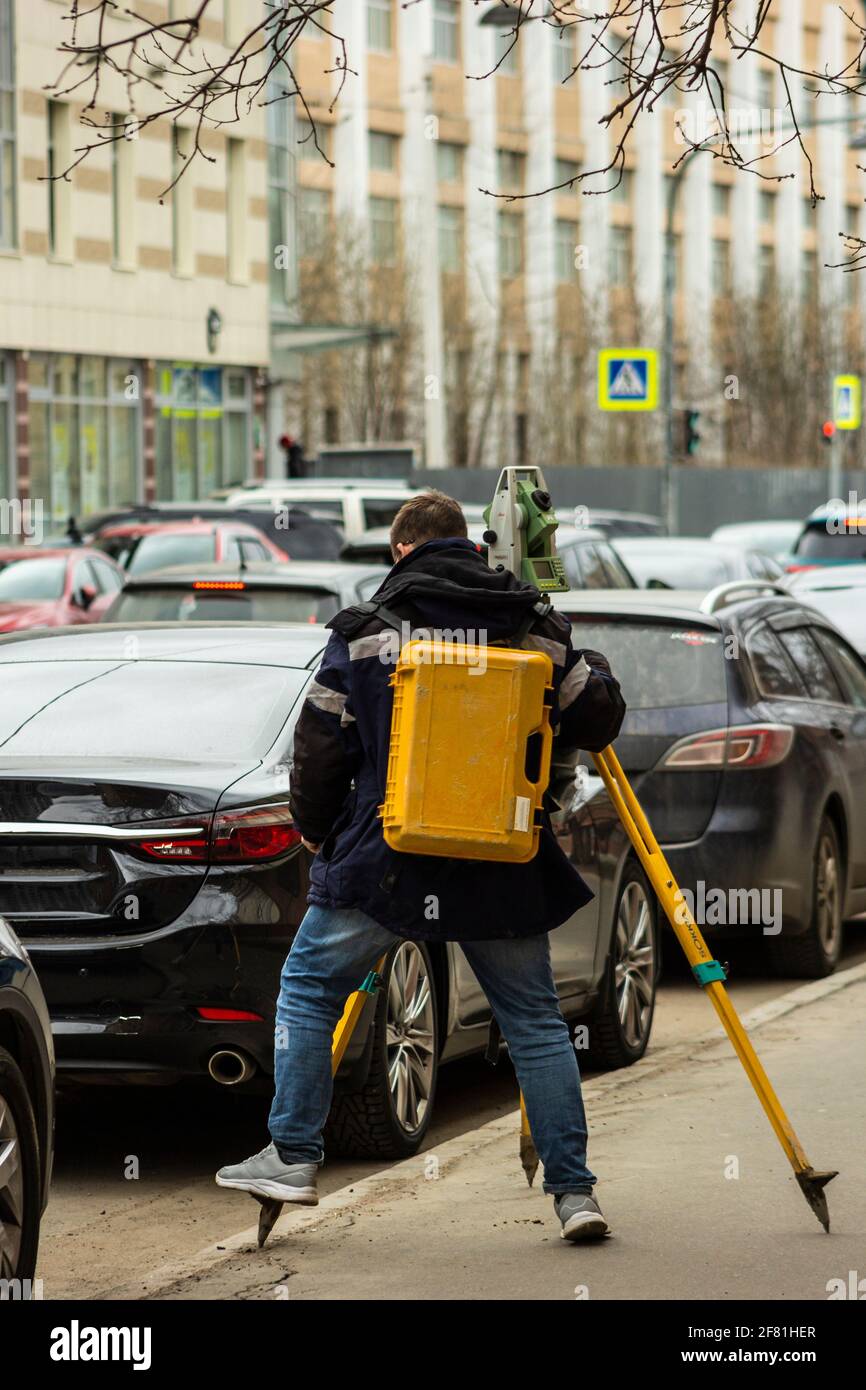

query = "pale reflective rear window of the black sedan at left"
[0,659,307,776]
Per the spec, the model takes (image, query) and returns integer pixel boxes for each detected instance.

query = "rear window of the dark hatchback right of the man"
[571,614,727,709]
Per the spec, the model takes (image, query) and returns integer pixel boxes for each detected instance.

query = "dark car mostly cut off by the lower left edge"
[0,917,54,1284]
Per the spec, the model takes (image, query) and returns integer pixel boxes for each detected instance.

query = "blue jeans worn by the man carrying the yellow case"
[268,906,595,1193]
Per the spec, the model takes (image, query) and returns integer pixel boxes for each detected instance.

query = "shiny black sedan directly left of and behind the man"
[0,625,657,1156]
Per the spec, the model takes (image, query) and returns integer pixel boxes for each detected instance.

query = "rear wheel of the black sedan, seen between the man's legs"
[324,941,439,1158]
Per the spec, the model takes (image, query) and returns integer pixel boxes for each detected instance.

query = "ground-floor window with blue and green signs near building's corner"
[156,361,252,502]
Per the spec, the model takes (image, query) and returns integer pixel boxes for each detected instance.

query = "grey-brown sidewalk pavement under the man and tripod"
[107,965,866,1300]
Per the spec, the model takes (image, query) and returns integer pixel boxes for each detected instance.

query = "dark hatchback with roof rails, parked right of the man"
[555,581,866,977]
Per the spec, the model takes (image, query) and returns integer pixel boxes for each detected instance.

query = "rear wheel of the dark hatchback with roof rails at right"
[767,816,845,980]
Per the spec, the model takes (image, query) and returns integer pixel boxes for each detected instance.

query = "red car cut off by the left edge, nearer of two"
[0,545,124,632]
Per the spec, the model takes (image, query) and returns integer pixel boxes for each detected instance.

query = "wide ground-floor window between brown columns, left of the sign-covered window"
[28,353,142,524]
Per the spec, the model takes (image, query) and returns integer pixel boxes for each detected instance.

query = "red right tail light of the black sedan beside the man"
[128,805,300,865]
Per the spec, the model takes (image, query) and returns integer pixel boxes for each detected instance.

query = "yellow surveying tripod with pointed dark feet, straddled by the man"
[256,746,837,1245]
